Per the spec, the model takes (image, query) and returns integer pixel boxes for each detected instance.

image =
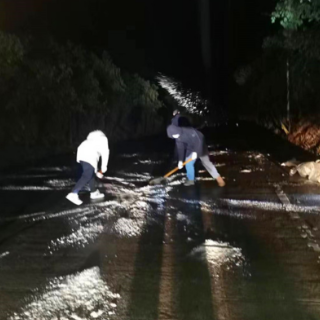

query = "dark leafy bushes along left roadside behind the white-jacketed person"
[0,32,173,148]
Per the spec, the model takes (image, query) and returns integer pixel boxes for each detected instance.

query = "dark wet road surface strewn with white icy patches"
[0,123,320,320]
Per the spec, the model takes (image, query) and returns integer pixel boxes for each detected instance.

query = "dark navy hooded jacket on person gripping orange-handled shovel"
[167,125,208,161]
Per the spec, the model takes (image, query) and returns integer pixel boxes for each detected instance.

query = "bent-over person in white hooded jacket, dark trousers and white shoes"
[66,130,110,206]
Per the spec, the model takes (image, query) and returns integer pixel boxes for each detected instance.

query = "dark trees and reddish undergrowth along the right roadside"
[234,0,320,154]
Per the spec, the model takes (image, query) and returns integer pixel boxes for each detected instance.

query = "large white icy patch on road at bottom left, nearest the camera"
[9,267,120,320]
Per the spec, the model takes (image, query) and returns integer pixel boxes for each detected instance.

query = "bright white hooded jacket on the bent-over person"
[77,130,110,172]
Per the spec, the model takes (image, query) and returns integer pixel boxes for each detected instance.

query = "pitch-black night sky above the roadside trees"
[0,0,275,107]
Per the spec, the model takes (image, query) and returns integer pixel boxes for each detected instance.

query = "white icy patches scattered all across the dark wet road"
[0,150,320,320]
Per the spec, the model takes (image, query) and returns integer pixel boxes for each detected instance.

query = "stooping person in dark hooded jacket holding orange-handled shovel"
[167,124,225,187]
